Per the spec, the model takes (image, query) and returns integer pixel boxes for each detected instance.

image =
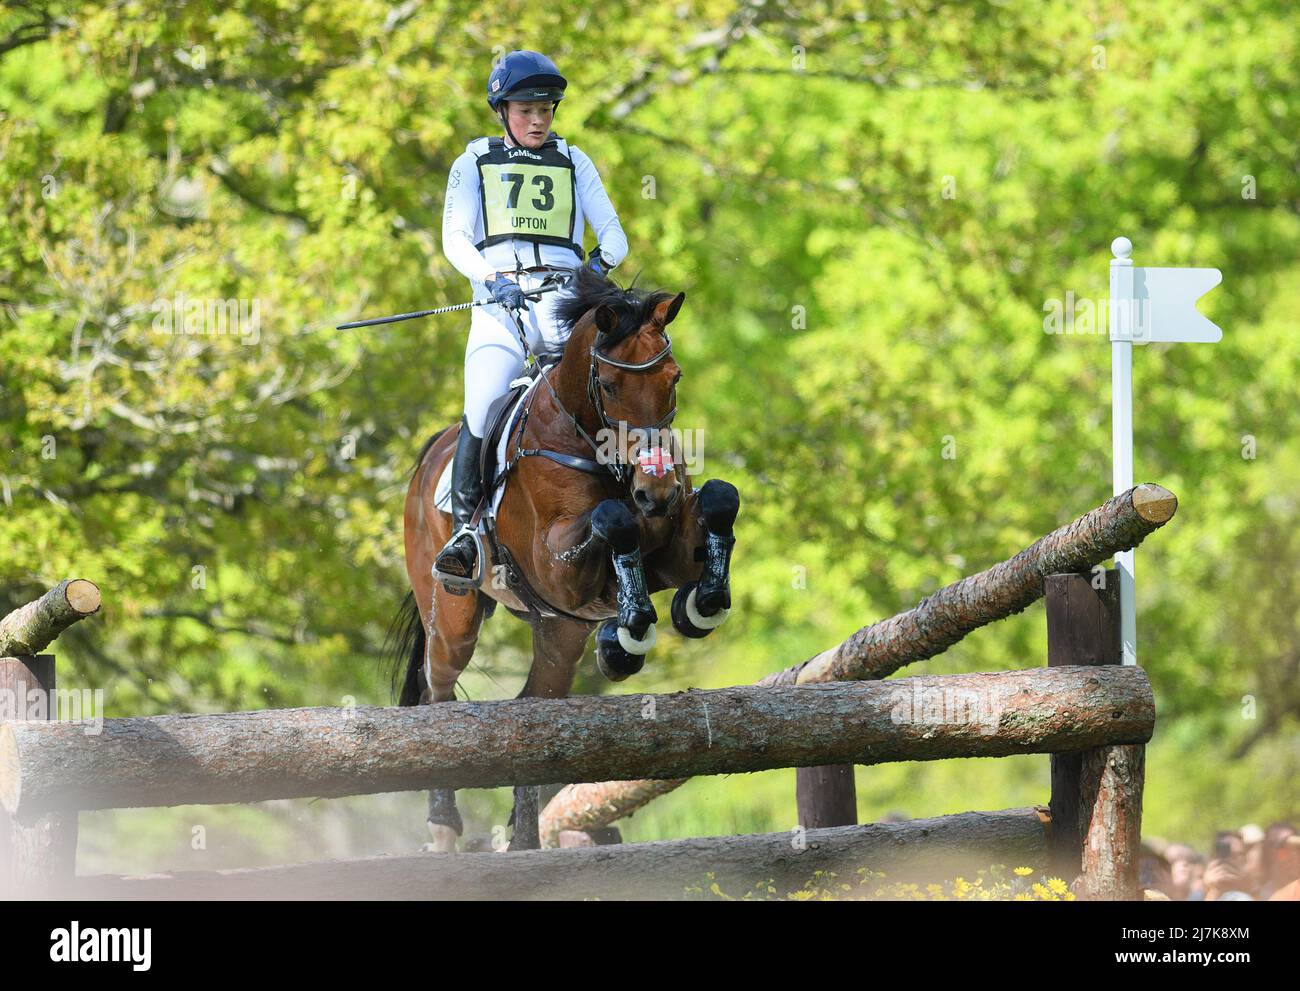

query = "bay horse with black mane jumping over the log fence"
[393,268,740,852]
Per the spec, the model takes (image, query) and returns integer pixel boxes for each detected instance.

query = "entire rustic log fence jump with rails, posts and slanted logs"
[0,484,1177,899]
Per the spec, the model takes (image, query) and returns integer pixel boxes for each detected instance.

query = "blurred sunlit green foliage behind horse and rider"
[0,0,1300,867]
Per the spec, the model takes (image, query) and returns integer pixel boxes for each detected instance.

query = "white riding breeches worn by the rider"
[465,272,568,437]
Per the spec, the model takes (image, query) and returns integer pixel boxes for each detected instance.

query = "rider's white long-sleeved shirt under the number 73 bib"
[442,131,628,287]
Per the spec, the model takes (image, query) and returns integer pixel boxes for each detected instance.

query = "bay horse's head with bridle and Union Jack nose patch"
[559,269,686,516]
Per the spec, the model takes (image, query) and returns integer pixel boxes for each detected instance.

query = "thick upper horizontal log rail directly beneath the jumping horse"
[0,666,1154,819]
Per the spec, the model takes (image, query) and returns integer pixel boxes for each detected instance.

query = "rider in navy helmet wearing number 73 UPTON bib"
[433,51,628,577]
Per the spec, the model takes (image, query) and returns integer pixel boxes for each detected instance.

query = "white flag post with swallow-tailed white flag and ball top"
[1109,238,1223,665]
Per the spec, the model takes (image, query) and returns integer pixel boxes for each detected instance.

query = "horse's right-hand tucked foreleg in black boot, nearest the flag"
[651,479,740,637]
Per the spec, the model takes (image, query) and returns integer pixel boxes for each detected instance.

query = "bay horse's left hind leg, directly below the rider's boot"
[420,580,486,853]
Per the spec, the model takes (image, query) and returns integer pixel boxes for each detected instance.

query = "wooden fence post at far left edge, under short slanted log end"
[0,654,77,899]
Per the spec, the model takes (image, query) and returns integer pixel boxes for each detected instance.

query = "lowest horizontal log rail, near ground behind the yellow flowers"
[70,809,1050,901]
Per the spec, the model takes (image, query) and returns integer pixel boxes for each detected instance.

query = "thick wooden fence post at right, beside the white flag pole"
[1044,570,1147,901]
